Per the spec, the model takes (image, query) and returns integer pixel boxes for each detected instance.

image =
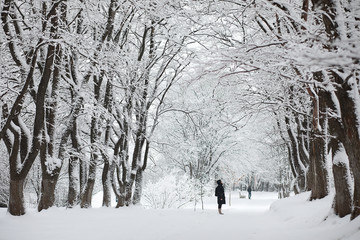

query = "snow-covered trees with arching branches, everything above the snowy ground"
[0,0,360,223]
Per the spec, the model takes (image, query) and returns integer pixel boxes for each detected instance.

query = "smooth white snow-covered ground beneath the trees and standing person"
[0,192,360,240]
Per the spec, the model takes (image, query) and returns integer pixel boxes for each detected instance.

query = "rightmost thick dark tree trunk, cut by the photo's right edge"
[312,0,360,219]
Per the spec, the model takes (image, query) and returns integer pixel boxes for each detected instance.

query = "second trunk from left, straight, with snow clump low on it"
[38,0,67,211]
